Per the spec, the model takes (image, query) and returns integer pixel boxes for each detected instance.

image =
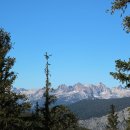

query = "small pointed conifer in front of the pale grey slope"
[107,104,118,130]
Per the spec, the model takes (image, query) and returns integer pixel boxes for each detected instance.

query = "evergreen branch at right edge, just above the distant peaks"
[110,59,130,87]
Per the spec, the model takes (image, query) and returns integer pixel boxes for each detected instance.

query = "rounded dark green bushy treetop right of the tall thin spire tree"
[51,105,78,130]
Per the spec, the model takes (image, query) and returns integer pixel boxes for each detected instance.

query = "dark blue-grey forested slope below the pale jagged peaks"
[69,97,130,120]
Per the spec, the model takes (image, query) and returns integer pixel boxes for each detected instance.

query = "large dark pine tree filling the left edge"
[0,29,30,130]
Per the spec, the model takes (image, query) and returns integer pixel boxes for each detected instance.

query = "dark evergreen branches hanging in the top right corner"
[111,0,130,33]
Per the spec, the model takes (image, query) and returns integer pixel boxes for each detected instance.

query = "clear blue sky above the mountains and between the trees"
[0,0,130,88]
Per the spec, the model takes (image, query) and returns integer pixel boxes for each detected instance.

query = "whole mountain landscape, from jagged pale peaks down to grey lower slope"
[12,83,130,130]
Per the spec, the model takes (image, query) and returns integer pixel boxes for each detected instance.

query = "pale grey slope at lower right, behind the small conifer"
[79,108,129,130]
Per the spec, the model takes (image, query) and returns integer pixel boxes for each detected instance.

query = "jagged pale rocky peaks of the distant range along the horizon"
[13,83,130,105]
